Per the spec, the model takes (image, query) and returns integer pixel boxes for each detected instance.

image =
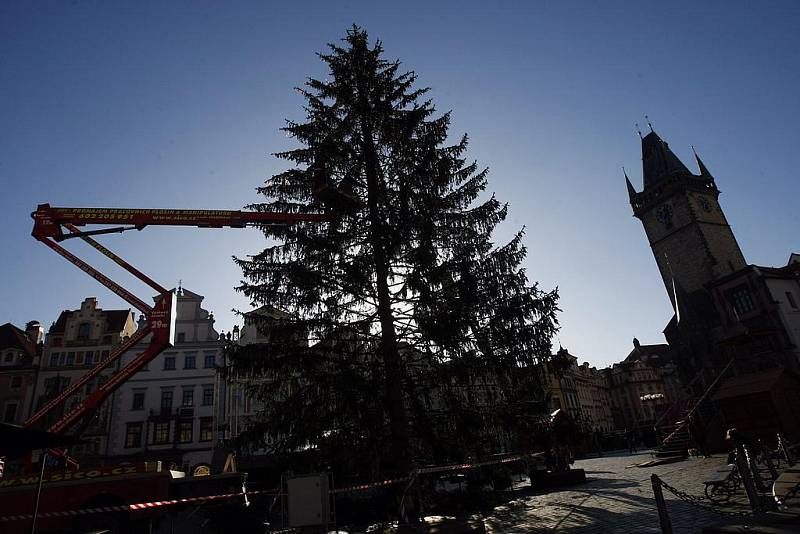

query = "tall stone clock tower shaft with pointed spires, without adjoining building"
[625,131,746,312]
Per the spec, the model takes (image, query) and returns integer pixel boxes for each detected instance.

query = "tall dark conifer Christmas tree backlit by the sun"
[222,27,557,482]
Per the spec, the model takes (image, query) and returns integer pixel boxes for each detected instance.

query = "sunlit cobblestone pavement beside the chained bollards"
[472,453,748,534]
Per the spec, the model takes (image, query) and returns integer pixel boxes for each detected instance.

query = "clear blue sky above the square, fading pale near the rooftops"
[0,0,800,366]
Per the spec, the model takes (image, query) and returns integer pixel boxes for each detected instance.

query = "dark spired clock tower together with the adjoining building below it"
[625,132,800,386]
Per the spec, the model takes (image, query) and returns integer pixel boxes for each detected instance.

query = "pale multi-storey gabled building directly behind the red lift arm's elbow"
[108,288,227,475]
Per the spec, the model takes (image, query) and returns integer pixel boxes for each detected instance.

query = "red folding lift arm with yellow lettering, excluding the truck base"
[24,205,334,440]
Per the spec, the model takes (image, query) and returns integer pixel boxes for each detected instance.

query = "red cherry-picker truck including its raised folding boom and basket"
[0,200,350,534]
